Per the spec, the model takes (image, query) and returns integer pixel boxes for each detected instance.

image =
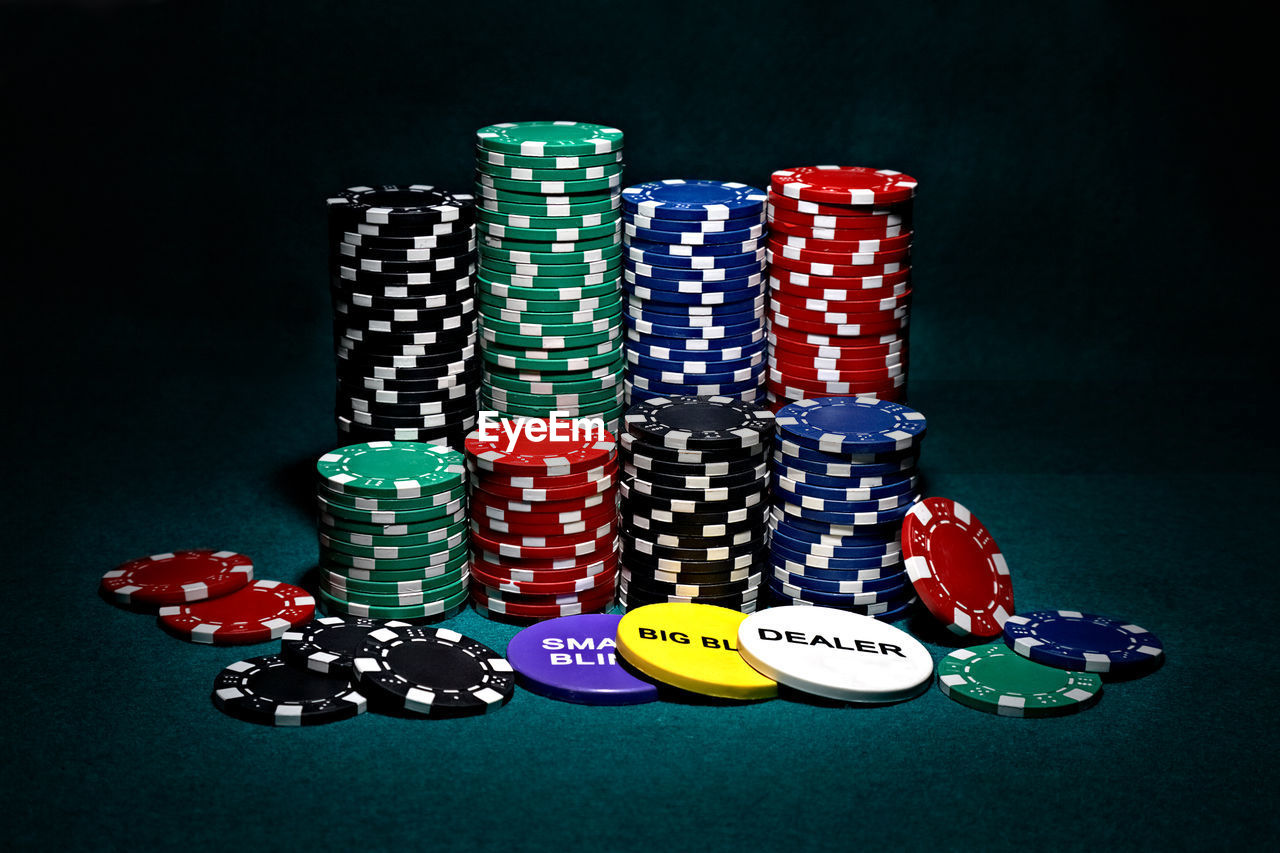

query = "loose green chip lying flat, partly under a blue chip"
[938,643,1102,717]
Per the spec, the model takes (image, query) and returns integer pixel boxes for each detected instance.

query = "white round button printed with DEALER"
[737,607,933,703]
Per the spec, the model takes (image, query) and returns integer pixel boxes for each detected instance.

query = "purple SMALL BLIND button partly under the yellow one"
[507,613,658,706]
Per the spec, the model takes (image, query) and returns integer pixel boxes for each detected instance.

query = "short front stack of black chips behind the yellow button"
[620,396,773,612]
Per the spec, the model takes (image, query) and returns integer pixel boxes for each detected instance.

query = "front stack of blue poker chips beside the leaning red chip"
[769,397,925,620]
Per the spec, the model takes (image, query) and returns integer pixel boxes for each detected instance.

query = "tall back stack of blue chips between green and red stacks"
[622,181,765,403]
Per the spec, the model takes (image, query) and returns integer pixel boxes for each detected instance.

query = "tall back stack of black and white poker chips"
[329,184,480,448]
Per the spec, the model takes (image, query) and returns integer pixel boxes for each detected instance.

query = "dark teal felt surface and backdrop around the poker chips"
[0,0,1280,850]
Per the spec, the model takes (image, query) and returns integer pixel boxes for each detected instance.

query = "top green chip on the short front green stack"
[316,442,466,498]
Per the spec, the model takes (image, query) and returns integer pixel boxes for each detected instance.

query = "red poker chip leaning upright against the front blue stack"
[902,497,1014,637]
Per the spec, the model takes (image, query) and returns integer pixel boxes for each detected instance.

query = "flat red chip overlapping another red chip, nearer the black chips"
[159,580,316,646]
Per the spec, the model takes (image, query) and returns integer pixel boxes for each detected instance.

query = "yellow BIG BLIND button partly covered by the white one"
[617,603,778,701]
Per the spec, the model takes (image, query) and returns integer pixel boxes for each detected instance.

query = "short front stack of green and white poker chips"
[316,442,470,620]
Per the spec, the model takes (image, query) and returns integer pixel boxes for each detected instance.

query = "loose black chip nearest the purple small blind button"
[352,625,516,717]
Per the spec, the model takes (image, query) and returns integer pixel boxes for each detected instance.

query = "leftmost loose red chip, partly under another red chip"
[100,549,253,606]
